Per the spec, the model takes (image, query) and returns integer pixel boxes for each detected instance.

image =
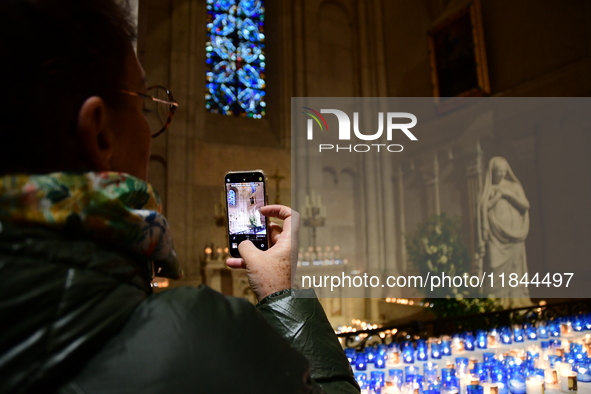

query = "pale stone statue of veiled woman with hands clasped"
[478,156,531,308]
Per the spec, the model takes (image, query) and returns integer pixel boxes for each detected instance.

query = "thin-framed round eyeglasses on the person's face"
[119,85,179,138]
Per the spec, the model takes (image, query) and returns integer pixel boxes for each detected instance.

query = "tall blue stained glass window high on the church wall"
[205,0,267,119]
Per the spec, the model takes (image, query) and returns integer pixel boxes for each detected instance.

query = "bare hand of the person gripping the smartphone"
[226,205,300,301]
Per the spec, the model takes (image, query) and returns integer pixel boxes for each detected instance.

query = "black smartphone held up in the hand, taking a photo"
[224,170,269,257]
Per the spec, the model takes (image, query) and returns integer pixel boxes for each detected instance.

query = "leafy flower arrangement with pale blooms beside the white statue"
[406,214,501,317]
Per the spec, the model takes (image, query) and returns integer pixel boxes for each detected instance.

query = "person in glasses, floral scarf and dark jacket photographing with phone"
[0,0,359,393]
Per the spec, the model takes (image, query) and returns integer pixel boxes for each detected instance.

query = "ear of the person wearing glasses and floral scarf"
[78,96,114,171]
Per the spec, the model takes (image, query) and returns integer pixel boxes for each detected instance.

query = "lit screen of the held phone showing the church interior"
[226,182,268,254]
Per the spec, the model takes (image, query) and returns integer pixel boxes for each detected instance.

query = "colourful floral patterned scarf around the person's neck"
[0,172,182,279]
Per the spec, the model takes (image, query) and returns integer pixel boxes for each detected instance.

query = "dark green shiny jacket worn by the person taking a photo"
[0,222,359,394]
